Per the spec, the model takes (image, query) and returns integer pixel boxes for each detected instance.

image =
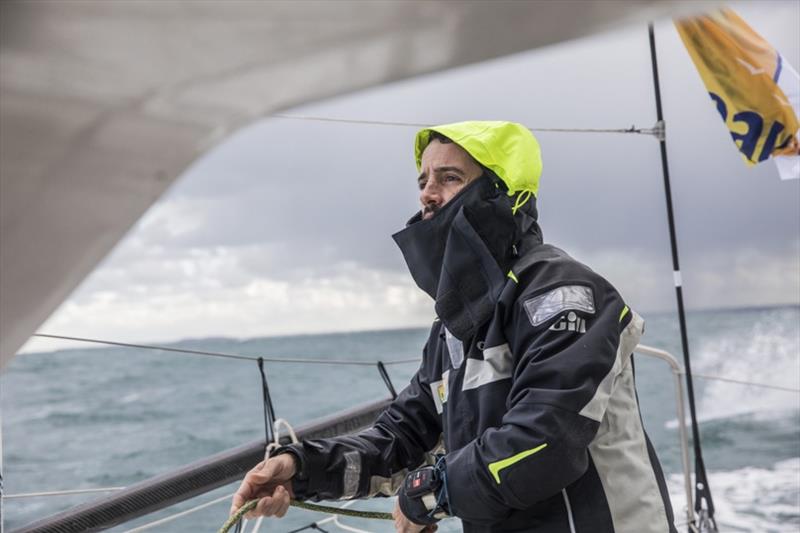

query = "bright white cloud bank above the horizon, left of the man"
[23,247,433,351]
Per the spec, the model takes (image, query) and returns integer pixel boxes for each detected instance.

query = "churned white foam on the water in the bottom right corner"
[668,457,800,533]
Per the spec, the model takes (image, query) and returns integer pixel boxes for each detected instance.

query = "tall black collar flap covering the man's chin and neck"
[393,175,520,340]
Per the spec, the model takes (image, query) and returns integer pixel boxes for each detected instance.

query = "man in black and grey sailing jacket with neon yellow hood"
[232,122,676,533]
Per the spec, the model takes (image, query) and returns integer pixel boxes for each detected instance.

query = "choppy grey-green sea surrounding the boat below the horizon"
[0,307,800,533]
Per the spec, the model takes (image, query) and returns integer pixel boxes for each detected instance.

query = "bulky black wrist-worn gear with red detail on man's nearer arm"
[397,458,449,526]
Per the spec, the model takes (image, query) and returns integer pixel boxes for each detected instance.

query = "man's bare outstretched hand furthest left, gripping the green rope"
[230,453,297,519]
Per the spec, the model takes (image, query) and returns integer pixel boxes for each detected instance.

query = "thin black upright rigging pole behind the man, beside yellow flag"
[647,22,717,533]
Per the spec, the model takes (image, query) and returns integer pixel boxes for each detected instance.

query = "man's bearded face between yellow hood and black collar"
[417,139,483,220]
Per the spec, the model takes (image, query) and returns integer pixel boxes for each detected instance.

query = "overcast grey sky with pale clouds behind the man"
[23,1,800,351]
